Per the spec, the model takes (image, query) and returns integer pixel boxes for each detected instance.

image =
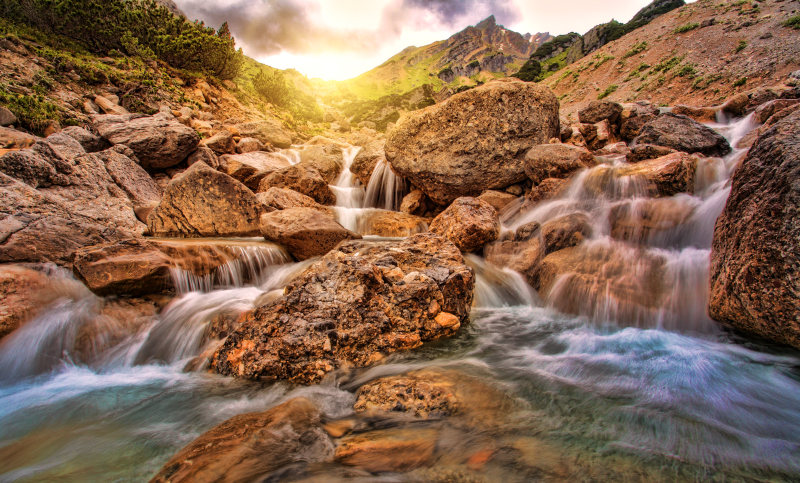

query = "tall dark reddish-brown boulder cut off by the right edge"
[709,112,800,348]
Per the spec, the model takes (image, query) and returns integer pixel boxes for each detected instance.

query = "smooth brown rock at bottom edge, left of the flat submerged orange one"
[151,398,334,483]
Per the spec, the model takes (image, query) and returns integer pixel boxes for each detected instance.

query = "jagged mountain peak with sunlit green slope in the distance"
[318,15,551,100]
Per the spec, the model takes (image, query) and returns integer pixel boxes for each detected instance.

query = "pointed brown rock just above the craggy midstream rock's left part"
[261,208,361,260]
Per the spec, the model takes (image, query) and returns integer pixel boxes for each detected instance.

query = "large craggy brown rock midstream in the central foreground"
[212,233,475,383]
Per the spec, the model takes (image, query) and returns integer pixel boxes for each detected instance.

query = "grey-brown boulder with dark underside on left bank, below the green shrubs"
[93,113,200,169]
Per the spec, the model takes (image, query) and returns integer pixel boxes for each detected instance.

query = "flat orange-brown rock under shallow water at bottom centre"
[334,428,439,473]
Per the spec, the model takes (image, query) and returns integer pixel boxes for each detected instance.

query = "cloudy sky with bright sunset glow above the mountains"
[174,0,668,80]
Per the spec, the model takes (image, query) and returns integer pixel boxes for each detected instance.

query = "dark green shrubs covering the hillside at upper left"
[0,0,244,79]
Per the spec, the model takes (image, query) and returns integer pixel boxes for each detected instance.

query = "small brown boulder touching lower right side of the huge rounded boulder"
[525,144,595,185]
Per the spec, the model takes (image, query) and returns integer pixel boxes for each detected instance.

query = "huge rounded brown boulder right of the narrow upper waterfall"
[385,79,559,205]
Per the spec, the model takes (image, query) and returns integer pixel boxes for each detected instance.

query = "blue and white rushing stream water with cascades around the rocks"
[0,119,800,481]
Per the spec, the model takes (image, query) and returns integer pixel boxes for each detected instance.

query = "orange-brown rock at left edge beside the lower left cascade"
[0,265,50,339]
